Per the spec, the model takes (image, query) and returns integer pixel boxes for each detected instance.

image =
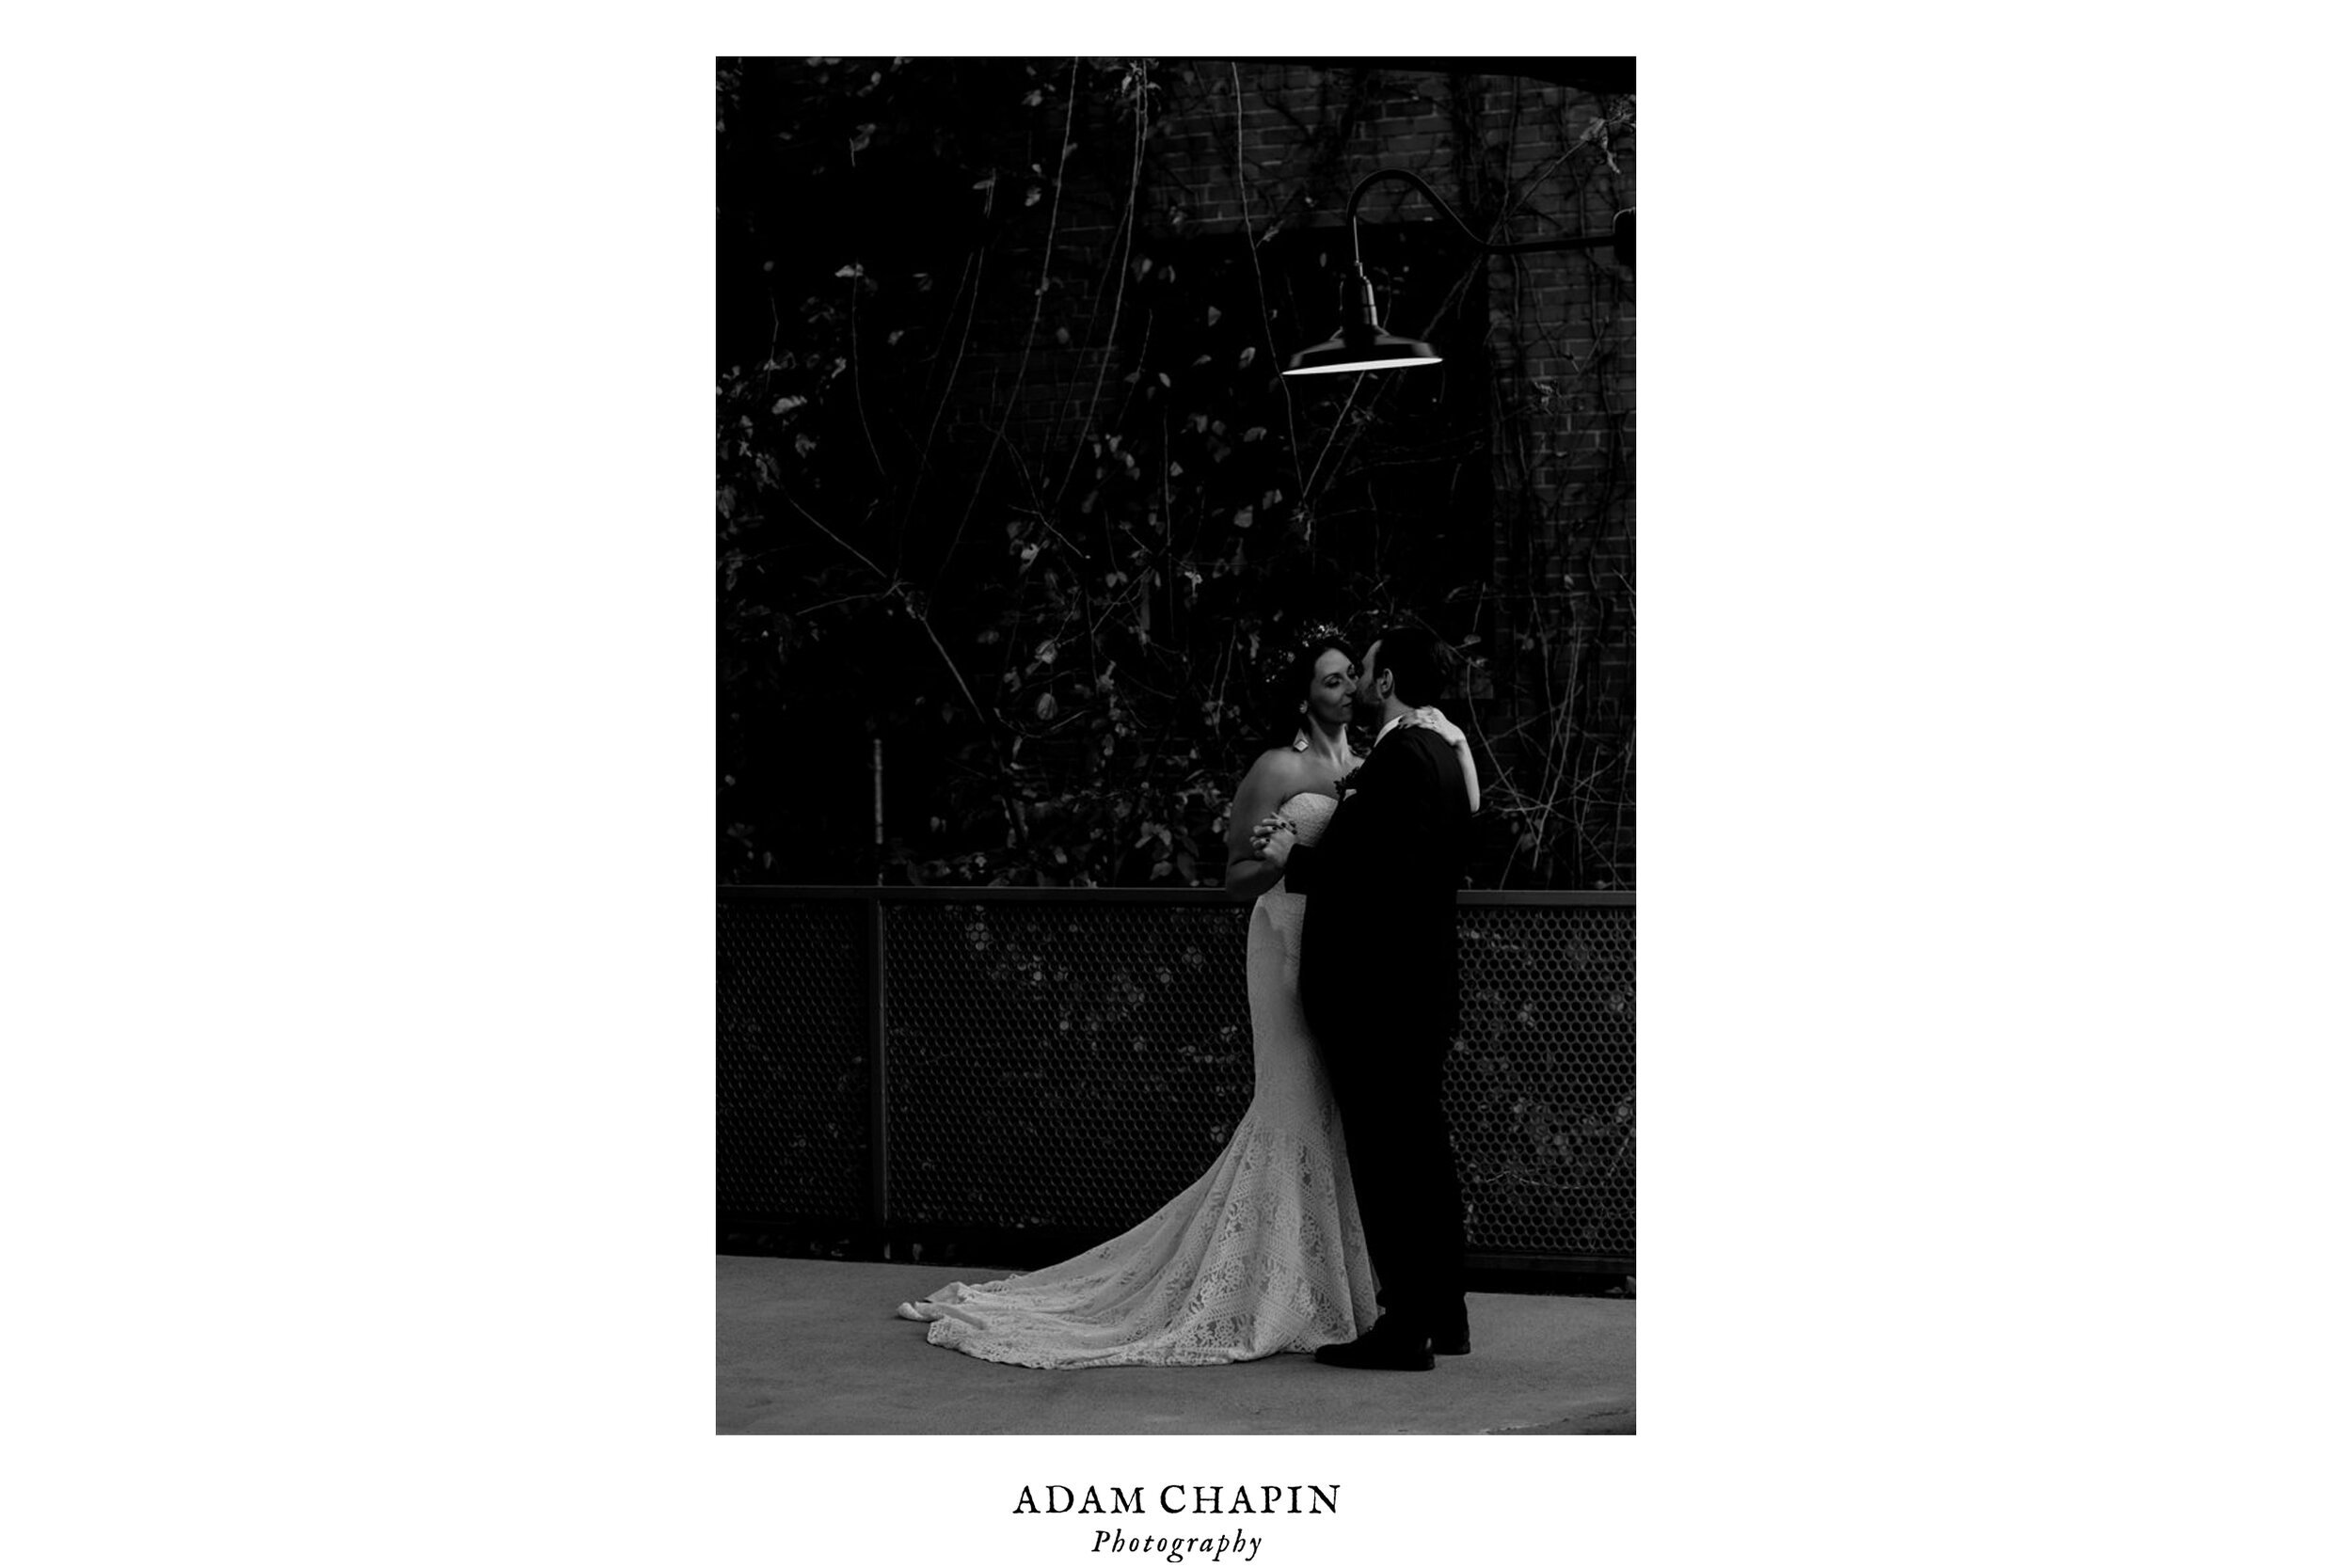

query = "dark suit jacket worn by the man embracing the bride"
[1284,726,1470,1053]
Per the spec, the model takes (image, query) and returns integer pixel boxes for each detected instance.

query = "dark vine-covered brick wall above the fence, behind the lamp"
[718,58,1632,889]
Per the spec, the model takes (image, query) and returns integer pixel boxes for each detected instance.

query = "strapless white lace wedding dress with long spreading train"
[898,795,1378,1366]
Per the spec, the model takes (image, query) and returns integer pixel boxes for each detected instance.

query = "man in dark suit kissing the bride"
[1251,627,1470,1370]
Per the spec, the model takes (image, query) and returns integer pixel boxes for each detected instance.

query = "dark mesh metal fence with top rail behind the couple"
[718,886,1635,1272]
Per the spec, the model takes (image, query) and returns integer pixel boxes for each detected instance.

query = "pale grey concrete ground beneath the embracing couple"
[718,1256,1635,1436]
